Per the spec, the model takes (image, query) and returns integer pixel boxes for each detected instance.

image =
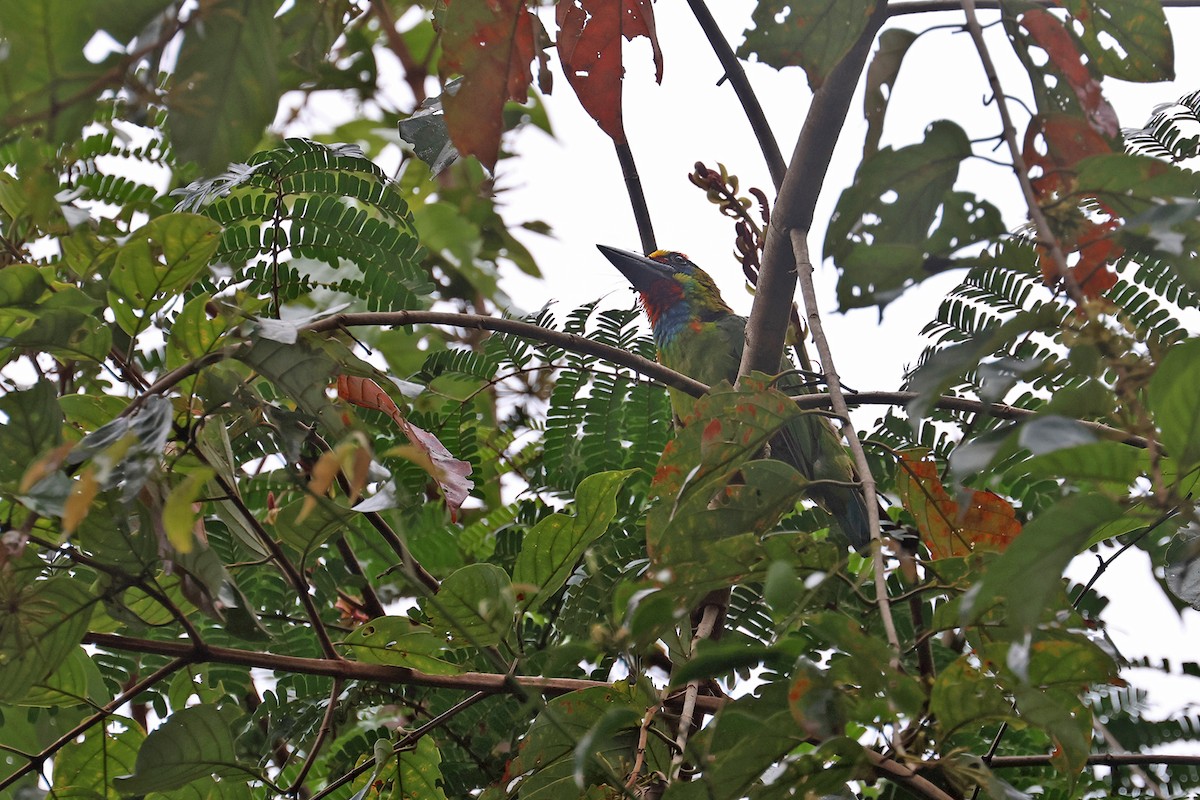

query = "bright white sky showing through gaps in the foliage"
[278,0,1200,714]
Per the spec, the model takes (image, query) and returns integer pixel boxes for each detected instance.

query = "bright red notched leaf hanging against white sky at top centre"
[558,0,662,144]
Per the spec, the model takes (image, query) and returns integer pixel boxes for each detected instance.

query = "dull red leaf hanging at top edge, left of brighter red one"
[437,0,535,169]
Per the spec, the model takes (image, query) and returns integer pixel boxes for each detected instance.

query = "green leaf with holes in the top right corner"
[1062,0,1175,82]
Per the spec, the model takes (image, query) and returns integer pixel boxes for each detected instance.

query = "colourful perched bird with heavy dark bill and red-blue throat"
[598,245,870,549]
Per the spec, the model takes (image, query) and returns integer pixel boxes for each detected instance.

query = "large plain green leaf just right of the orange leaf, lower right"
[961,494,1121,631]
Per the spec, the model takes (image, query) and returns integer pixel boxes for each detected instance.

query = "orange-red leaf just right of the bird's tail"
[899,452,1021,559]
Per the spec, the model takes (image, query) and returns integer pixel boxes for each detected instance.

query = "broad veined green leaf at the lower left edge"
[0,560,96,703]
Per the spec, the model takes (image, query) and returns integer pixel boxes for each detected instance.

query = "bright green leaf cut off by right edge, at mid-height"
[1148,339,1200,473]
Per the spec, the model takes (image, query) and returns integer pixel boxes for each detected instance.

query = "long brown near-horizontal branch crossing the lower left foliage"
[83,632,727,714]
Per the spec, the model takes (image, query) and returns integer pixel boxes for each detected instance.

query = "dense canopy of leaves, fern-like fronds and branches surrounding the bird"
[0,0,1200,800]
